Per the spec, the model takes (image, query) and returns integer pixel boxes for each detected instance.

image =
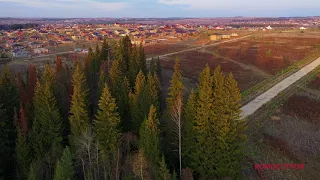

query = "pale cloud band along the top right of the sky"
[158,0,320,12]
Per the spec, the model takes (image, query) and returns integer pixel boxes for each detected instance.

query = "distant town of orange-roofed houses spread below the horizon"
[0,17,320,59]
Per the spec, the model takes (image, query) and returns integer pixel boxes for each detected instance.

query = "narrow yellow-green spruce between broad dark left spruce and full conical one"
[69,64,89,140]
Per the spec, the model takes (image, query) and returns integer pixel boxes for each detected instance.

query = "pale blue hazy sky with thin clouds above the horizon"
[0,0,320,18]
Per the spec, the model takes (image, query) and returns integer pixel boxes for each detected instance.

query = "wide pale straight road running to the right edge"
[241,57,320,118]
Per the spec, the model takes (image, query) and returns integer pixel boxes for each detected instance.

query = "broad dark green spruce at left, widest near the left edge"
[30,75,64,178]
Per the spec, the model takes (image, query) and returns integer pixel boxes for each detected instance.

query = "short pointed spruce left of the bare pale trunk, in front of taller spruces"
[140,105,160,164]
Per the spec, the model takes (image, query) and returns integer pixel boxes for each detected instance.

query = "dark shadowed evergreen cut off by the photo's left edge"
[0,66,19,179]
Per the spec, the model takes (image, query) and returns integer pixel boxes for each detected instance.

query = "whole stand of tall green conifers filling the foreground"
[0,37,246,180]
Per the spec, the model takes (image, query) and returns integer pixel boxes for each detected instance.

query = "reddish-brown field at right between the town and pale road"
[207,35,320,74]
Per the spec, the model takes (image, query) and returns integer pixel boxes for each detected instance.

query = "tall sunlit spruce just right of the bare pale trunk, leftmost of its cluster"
[192,65,216,178]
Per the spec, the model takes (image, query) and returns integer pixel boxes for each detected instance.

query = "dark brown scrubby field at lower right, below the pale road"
[250,90,320,179]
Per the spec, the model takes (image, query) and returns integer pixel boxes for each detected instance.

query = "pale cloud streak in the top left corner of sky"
[0,0,129,11]
